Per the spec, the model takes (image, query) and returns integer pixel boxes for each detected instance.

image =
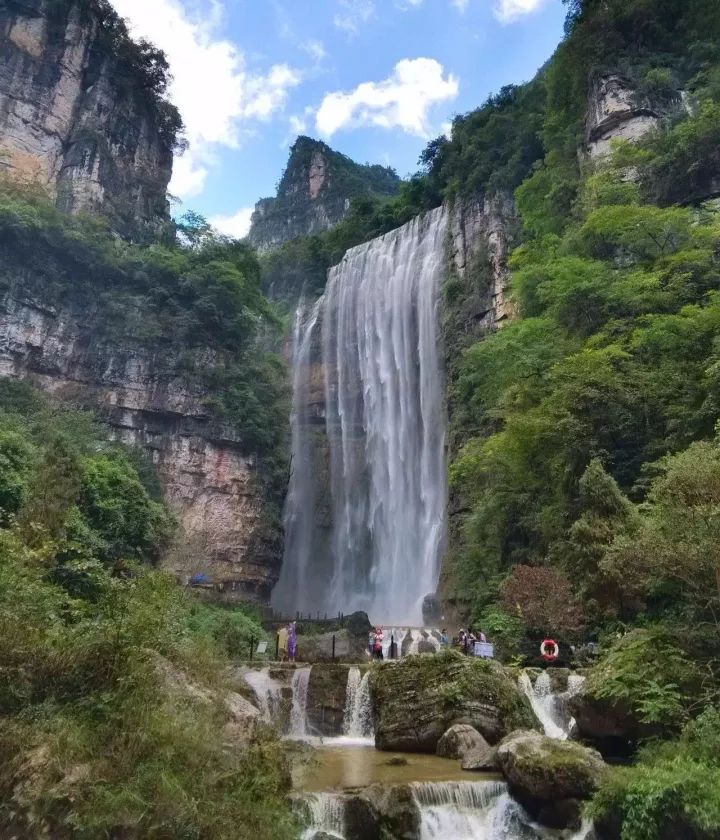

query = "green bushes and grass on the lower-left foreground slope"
[0,380,293,838]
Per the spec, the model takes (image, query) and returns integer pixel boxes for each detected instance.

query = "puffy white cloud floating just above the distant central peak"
[315,58,459,137]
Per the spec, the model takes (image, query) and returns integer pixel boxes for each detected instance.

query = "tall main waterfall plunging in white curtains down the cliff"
[272,208,447,626]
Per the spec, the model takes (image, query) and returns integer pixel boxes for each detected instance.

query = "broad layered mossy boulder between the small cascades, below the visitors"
[370,651,537,753]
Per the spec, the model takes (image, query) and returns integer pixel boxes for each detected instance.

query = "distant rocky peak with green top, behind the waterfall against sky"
[249,137,400,251]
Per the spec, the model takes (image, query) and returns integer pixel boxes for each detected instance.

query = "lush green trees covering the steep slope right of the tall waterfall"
[430,0,720,840]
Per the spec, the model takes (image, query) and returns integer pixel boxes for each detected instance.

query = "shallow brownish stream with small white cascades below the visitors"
[244,664,592,840]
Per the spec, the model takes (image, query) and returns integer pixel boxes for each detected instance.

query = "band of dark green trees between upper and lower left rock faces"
[0,183,288,503]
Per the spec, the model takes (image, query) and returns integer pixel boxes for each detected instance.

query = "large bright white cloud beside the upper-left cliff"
[112,0,300,198]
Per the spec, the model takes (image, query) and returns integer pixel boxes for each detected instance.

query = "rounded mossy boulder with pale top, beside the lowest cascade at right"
[497,731,607,828]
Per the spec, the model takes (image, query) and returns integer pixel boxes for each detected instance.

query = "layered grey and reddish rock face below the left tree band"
[0,286,282,602]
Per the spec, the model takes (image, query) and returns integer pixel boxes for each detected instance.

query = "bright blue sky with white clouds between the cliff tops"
[112,0,564,236]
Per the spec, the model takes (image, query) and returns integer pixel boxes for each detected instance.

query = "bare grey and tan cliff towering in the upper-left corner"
[0,0,177,237]
